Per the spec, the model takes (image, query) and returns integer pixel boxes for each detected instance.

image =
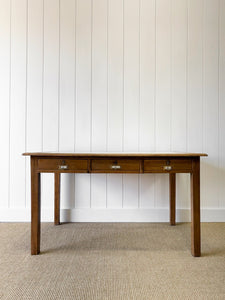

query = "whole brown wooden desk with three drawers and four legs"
[23,153,207,256]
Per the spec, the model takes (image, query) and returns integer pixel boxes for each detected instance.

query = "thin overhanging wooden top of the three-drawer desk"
[23,152,208,157]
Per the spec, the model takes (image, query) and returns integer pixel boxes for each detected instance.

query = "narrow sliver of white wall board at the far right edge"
[218,0,225,208]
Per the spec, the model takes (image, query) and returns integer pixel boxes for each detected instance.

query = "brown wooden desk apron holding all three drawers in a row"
[32,156,199,173]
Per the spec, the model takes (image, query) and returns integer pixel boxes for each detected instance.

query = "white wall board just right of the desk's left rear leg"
[59,0,76,208]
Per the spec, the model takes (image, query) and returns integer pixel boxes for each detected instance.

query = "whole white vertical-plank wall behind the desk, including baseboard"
[0,0,225,221]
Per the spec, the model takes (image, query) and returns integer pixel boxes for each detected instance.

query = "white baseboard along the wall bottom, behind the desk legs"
[0,208,225,222]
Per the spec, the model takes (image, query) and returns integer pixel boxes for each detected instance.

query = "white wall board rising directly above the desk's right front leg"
[187,0,203,152]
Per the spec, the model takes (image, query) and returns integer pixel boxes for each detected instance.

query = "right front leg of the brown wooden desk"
[191,157,201,256]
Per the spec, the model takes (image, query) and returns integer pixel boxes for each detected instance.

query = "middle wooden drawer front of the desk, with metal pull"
[91,159,140,173]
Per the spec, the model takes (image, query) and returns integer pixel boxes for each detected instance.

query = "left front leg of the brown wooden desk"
[31,157,41,255]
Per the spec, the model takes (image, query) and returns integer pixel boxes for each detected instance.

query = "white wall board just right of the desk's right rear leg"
[171,0,190,207]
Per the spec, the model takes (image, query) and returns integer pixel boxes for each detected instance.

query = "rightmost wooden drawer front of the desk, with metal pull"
[144,159,192,173]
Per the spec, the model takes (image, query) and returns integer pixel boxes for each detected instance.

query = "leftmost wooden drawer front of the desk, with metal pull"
[37,158,88,172]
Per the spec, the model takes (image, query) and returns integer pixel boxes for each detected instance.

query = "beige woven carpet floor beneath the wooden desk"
[0,223,225,300]
